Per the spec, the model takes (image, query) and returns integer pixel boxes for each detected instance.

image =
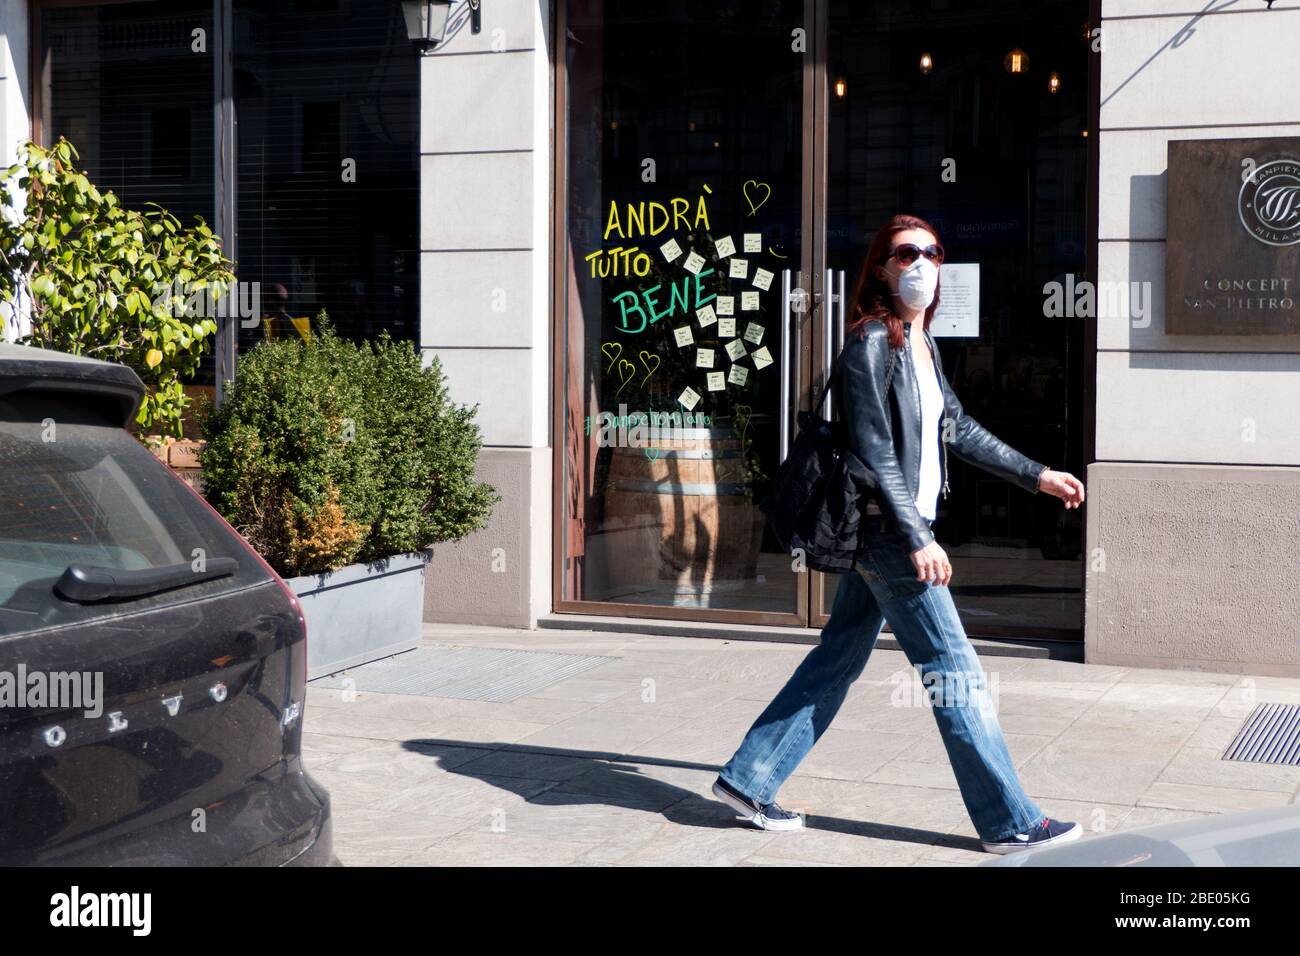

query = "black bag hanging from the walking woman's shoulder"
[758,349,894,574]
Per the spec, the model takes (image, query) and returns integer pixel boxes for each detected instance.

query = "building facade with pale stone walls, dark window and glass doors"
[0,0,1300,676]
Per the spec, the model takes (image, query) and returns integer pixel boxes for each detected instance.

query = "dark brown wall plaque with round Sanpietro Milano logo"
[1165,137,1300,336]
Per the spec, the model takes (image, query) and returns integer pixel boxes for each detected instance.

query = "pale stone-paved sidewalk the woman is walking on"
[304,626,1300,866]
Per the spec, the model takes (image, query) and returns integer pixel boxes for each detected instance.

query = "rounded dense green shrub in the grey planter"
[202,313,501,576]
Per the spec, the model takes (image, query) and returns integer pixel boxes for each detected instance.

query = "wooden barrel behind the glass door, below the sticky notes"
[602,428,764,606]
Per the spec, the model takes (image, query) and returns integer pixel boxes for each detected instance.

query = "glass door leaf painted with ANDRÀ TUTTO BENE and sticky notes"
[555,0,814,626]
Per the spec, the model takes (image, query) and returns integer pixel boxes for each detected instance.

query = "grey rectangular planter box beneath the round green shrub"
[285,551,429,680]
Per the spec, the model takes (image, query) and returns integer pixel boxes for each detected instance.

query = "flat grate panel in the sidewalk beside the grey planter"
[312,646,618,704]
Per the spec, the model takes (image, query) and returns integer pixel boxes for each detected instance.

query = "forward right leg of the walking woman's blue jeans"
[858,533,1044,840]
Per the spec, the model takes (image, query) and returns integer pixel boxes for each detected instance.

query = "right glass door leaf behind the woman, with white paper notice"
[813,0,1093,640]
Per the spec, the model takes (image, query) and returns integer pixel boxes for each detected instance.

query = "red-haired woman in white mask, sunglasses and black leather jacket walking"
[714,216,1084,853]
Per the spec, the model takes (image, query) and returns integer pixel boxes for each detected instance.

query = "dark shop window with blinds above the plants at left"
[34,0,420,392]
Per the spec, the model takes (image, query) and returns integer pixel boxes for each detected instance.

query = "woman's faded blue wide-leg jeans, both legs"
[720,516,1044,840]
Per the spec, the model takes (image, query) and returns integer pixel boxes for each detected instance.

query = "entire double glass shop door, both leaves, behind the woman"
[554,0,1096,639]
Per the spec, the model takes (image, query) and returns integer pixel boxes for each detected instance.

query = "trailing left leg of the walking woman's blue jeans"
[719,571,884,804]
